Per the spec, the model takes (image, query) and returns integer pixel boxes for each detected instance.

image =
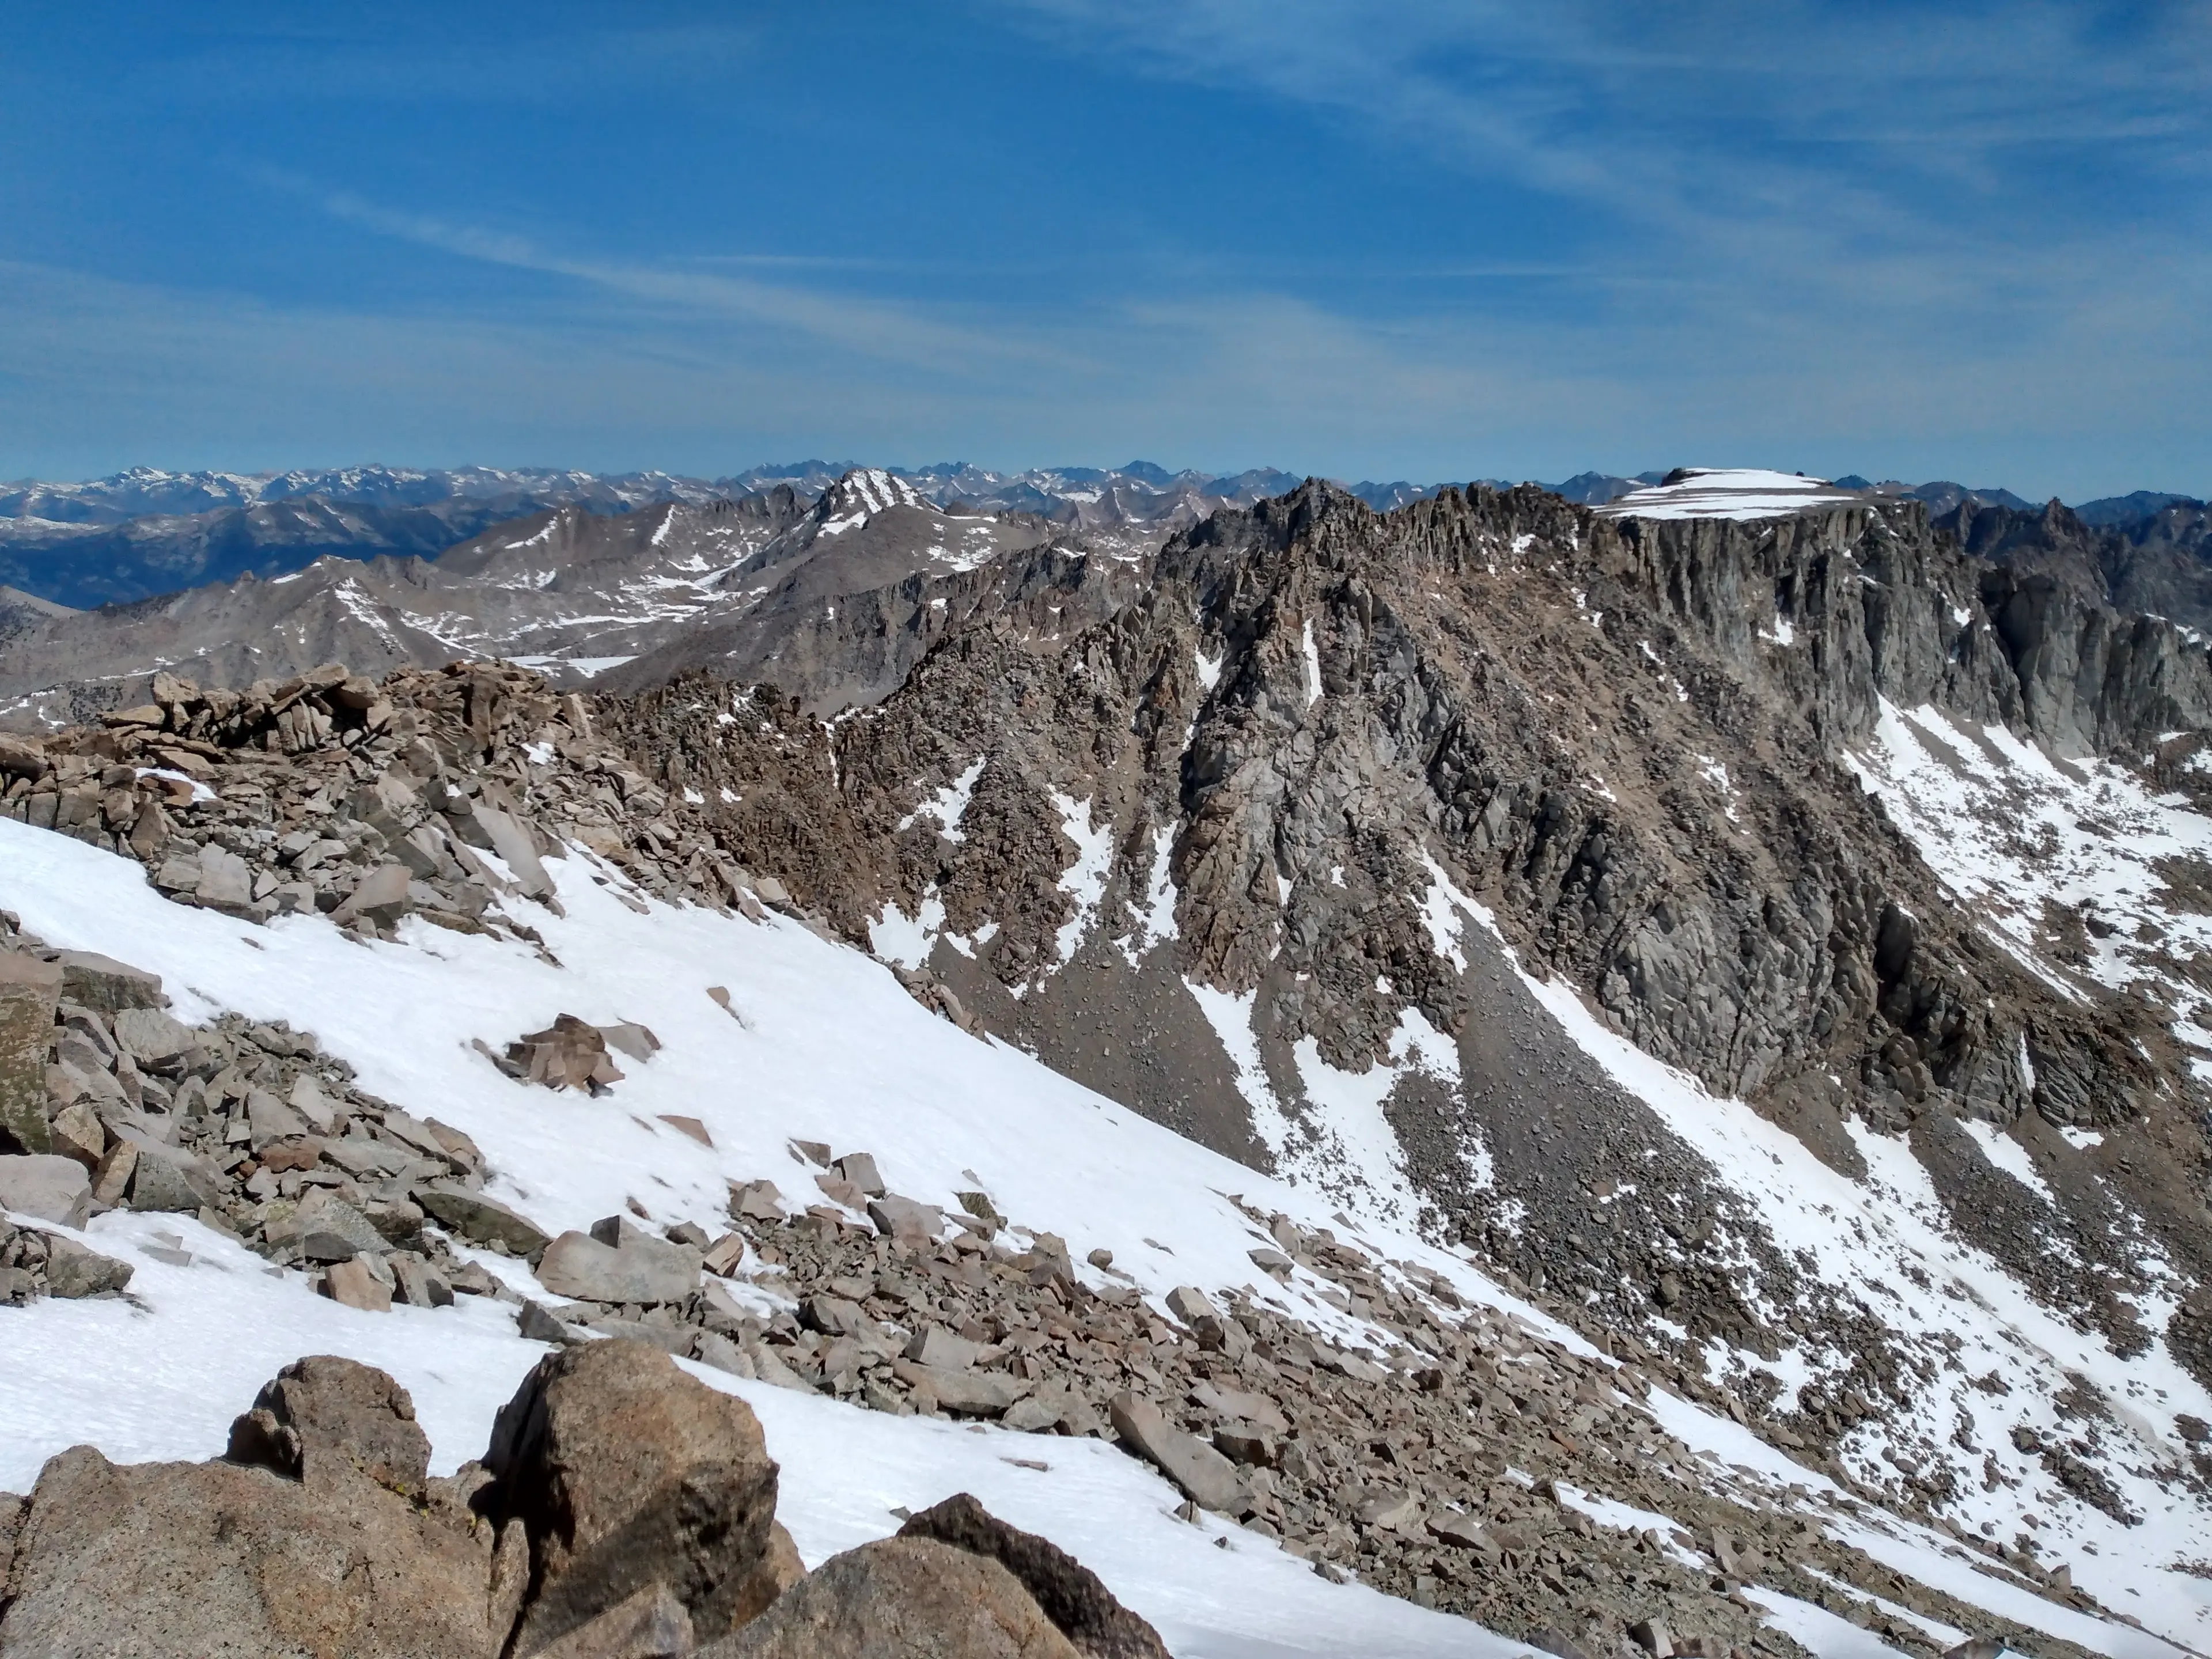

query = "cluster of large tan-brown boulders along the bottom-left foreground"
[0,1340,1194,1659]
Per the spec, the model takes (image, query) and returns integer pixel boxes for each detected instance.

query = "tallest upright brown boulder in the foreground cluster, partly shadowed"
[482,1338,803,1654]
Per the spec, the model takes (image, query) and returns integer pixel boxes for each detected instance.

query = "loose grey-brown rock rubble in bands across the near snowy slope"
[9,666,2115,1652]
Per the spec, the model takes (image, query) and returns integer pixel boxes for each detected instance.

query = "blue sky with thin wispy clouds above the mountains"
[0,0,2212,500]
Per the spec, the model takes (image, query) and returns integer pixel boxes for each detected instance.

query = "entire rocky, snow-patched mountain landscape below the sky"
[0,463,2212,1659]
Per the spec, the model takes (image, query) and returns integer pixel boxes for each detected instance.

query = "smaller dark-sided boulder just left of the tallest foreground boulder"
[224,1354,429,1493]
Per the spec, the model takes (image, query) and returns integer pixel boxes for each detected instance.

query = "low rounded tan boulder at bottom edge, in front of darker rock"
[697,1537,1080,1659]
